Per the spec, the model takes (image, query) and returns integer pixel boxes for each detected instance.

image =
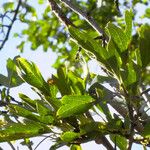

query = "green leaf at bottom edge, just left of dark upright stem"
[110,134,128,150]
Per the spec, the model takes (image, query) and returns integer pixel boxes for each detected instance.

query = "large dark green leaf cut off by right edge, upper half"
[139,25,150,68]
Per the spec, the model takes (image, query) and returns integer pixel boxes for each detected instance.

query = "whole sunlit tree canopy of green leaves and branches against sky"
[0,0,150,150]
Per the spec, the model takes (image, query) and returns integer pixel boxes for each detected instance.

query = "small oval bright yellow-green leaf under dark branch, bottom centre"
[60,131,80,142]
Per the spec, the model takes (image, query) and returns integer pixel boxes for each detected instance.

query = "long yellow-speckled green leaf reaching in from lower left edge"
[0,121,50,142]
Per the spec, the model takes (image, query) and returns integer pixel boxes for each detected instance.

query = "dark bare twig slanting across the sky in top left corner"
[0,0,21,50]
